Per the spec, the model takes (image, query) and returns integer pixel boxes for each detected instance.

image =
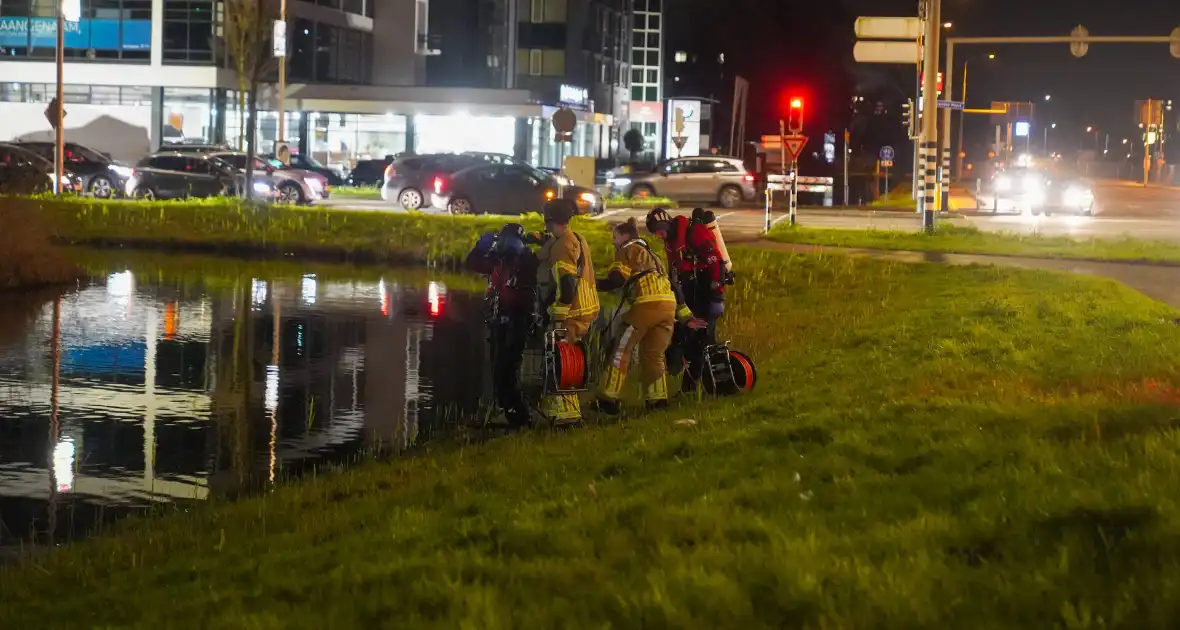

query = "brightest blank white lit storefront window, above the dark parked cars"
[414,113,516,156]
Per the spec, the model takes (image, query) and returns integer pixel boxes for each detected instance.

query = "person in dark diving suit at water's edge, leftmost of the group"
[467,223,537,428]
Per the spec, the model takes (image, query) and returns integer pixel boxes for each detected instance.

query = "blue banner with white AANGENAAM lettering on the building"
[0,18,151,51]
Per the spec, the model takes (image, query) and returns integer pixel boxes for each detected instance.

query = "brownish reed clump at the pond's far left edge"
[0,197,81,290]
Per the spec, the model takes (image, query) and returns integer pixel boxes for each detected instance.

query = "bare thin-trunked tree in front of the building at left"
[222,0,282,197]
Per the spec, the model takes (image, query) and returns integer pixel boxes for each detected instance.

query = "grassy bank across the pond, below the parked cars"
[23,198,612,263]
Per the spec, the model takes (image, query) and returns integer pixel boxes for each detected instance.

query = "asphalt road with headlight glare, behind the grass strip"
[325,182,1180,242]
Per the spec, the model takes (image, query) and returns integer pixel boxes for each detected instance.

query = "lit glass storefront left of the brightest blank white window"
[311,112,406,171]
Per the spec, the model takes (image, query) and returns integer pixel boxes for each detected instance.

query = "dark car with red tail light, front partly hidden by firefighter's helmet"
[431,164,604,215]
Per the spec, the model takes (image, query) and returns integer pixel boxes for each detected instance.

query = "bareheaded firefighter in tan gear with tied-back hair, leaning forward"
[597,218,691,414]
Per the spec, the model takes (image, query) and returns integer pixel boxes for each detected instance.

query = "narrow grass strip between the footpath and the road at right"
[769,224,1180,264]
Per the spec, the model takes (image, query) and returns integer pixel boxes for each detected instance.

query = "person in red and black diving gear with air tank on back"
[647,208,732,393]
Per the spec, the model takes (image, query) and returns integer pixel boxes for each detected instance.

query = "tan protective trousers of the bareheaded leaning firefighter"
[599,301,676,402]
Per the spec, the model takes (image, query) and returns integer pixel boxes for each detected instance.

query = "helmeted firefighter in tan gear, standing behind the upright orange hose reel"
[537,199,599,428]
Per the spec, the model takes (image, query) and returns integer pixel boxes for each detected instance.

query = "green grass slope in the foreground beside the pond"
[0,248,1180,629]
